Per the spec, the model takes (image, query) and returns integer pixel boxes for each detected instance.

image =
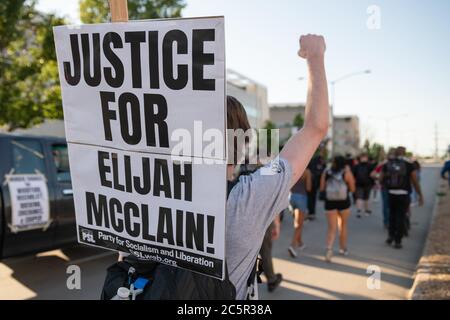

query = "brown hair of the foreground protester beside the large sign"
[227,96,250,164]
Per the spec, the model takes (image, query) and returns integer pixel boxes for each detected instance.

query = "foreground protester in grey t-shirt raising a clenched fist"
[102,34,329,300]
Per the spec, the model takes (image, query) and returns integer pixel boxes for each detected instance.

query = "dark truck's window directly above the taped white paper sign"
[11,140,46,174]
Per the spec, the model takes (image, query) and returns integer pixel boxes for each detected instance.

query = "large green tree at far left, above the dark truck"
[0,1,65,131]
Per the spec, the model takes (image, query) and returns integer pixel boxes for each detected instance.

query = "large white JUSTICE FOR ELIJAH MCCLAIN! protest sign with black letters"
[54,17,226,279]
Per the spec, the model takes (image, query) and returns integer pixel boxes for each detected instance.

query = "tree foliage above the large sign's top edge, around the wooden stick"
[80,0,186,23]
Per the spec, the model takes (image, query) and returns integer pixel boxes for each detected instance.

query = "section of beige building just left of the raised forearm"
[269,103,305,144]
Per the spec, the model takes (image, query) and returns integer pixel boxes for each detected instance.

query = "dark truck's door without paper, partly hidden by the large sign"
[48,141,77,245]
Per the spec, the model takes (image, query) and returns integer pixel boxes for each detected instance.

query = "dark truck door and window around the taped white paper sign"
[2,137,55,257]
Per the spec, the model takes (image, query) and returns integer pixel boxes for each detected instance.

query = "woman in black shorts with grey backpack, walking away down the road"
[320,156,355,262]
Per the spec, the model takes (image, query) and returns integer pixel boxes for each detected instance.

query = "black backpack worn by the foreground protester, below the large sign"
[101,182,261,300]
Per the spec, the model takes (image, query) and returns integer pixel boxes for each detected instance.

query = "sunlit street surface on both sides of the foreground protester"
[0,167,438,300]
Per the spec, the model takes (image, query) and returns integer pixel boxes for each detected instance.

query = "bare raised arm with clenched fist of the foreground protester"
[280,35,329,186]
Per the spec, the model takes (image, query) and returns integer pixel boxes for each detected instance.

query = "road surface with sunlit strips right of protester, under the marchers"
[259,167,438,300]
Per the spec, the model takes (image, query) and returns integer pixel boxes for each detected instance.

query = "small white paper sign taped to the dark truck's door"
[7,174,49,231]
